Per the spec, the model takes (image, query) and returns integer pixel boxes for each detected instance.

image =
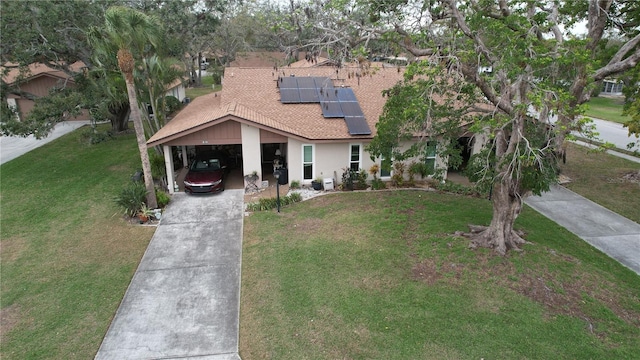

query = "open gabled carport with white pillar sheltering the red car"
[147,100,288,193]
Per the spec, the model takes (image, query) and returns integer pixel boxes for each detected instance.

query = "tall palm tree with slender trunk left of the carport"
[104,6,161,208]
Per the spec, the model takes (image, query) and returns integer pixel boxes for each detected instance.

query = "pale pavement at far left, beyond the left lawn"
[0,121,90,164]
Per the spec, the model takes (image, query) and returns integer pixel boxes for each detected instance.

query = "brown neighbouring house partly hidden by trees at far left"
[3,62,90,120]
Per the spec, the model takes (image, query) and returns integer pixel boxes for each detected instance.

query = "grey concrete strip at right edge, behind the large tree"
[525,185,640,275]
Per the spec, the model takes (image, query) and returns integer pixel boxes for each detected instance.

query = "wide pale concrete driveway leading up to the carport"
[96,190,244,360]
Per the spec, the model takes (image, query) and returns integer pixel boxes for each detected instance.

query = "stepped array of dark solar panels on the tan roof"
[278,76,371,135]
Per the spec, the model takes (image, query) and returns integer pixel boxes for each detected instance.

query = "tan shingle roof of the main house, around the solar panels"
[147,63,403,146]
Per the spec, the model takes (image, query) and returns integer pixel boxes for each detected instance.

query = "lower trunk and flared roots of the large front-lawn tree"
[464,180,526,255]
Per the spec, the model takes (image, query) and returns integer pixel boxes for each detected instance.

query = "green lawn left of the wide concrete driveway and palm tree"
[0,125,154,359]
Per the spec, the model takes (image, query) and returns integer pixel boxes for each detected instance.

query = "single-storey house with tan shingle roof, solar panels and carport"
[147,60,482,190]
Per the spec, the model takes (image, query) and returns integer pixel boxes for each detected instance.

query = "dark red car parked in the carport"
[184,154,226,194]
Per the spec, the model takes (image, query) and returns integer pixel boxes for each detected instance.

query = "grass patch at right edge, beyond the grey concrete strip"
[561,144,640,223]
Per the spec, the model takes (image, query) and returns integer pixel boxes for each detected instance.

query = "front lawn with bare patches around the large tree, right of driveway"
[240,191,640,360]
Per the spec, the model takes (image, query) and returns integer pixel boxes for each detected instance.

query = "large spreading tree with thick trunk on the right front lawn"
[360,0,640,254]
